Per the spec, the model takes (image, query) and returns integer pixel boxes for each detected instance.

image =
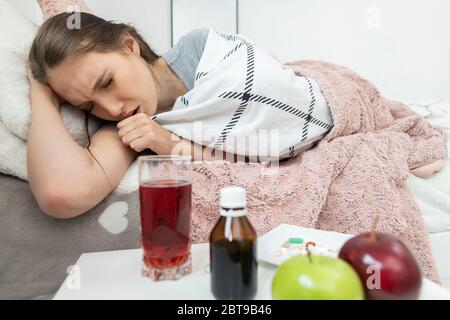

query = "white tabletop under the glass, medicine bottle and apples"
[54,225,450,300]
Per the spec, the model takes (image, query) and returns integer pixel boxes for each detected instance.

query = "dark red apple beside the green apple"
[339,232,422,300]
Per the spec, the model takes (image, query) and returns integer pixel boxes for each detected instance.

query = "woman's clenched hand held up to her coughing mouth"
[117,113,182,155]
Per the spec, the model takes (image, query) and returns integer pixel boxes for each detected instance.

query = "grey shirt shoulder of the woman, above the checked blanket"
[162,28,209,90]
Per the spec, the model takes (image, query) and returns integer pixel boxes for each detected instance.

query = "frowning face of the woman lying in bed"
[48,37,158,121]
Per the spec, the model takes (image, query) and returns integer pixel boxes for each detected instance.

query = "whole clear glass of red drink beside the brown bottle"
[138,155,192,280]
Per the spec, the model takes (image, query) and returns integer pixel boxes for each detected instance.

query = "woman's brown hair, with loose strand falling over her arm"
[28,12,159,188]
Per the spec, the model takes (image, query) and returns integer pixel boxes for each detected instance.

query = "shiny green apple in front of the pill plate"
[272,255,364,300]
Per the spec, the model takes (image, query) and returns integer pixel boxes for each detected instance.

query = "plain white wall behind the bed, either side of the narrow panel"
[9,0,450,100]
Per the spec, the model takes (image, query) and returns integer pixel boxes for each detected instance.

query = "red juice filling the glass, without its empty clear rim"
[139,180,192,269]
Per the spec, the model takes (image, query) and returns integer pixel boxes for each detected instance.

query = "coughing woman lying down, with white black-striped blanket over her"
[28,13,333,218]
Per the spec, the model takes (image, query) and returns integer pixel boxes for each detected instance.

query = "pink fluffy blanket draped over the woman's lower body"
[192,61,448,281]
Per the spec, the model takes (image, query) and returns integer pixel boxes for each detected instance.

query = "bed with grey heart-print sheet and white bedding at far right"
[0,148,450,299]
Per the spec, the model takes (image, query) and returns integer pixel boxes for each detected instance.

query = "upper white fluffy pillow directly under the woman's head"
[0,0,100,144]
